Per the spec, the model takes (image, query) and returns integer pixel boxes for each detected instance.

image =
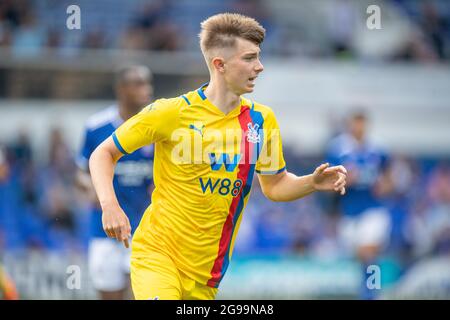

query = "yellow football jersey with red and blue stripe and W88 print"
[113,86,285,287]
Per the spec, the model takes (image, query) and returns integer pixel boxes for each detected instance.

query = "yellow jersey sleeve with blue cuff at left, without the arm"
[112,99,179,154]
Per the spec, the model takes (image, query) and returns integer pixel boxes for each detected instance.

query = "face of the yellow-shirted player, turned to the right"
[224,38,264,95]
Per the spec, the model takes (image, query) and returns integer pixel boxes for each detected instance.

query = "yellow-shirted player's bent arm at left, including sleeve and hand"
[89,98,181,246]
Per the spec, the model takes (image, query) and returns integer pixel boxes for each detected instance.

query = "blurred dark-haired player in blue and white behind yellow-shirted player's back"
[77,66,153,299]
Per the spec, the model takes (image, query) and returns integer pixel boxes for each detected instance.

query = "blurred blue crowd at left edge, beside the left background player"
[0,129,88,250]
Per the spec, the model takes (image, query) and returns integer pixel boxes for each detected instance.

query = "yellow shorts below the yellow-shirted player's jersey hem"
[131,251,218,300]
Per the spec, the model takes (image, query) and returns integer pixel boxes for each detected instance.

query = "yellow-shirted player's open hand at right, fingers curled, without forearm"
[313,163,347,195]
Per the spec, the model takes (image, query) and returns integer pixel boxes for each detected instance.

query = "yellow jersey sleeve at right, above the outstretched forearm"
[256,110,286,174]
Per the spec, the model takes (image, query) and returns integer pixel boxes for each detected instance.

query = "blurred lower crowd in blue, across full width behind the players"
[0,129,450,276]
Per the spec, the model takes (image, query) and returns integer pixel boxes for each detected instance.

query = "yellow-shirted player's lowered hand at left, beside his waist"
[102,206,131,248]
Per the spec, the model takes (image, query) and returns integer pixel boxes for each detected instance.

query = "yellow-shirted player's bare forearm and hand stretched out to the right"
[258,163,347,201]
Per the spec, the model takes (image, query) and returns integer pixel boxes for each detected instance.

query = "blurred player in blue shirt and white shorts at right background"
[327,111,392,299]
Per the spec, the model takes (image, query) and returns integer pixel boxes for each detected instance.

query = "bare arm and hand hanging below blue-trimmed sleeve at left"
[89,137,131,248]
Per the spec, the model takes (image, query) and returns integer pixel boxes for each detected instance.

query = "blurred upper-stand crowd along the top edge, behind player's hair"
[0,0,450,61]
